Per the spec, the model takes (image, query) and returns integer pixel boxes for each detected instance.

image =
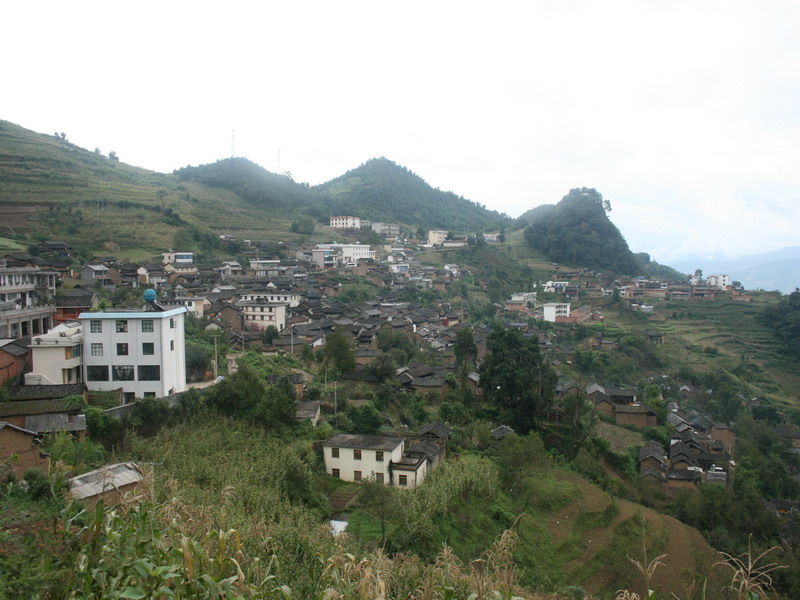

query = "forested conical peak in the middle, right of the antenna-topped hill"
[316,158,515,233]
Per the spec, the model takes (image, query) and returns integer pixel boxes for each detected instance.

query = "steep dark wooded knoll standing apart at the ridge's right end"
[525,188,644,275]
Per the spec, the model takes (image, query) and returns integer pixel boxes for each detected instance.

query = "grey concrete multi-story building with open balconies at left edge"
[0,267,58,339]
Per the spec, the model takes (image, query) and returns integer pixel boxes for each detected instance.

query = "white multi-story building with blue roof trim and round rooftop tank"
[78,308,186,402]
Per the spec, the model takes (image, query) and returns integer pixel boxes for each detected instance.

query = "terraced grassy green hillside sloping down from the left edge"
[0,121,338,260]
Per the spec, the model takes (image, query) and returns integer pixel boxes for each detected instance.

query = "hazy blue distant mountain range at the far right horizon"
[671,246,800,294]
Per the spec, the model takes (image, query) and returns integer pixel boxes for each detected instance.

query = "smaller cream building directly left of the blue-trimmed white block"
[25,321,83,385]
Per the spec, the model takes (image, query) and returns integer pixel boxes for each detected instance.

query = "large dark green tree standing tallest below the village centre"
[480,327,557,434]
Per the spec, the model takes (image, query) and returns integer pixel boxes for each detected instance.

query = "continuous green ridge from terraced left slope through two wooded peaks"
[0,121,516,255]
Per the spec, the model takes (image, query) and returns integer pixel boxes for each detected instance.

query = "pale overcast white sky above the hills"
[0,0,800,262]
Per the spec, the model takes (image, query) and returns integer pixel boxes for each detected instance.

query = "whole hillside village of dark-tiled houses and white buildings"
[0,216,776,506]
